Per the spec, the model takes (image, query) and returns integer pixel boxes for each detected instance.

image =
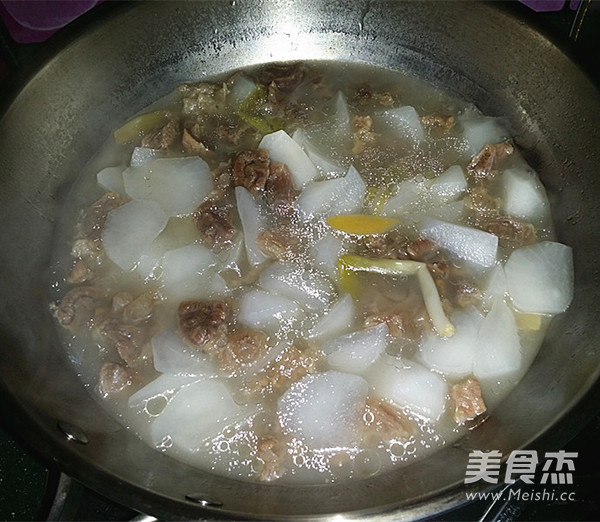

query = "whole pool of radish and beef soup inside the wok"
[51,63,573,483]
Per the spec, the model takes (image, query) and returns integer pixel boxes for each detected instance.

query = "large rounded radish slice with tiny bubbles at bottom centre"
[277,371,369,448]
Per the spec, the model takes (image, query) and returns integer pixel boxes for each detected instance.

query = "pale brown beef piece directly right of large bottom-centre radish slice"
[363,397,415,442]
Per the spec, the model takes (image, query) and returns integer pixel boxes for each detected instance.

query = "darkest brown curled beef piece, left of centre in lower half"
[178,301,229,346]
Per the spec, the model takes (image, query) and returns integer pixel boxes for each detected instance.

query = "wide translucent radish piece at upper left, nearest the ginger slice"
[123,157,212,216]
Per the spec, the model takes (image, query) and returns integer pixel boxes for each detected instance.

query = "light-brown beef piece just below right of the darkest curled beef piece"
[207,331,269,374]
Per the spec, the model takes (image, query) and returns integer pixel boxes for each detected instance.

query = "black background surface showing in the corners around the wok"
[0,0,600,521]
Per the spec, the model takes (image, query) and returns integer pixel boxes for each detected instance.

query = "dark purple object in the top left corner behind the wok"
[0,0,99,43]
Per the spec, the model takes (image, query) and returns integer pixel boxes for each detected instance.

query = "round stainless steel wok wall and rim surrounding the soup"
[0,0,600,519]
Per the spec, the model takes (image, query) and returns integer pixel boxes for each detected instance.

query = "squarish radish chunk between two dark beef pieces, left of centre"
[160,244,218,300]
